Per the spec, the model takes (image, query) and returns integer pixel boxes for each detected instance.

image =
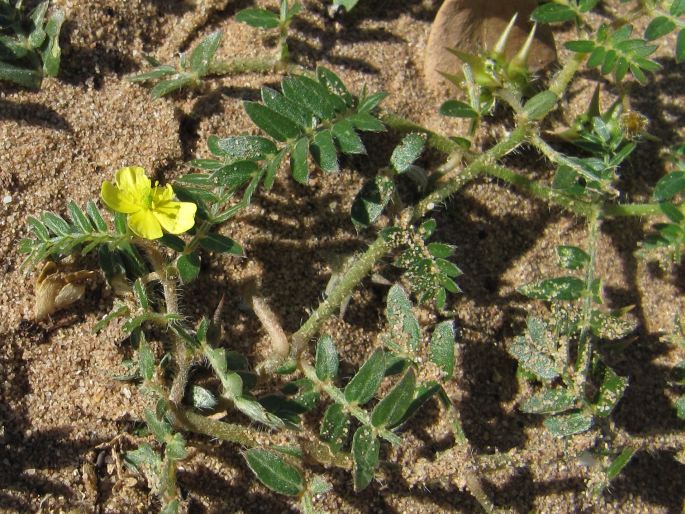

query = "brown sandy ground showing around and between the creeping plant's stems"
[0,0,685,513]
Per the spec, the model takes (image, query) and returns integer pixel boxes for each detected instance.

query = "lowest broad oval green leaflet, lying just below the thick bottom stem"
[244,448,304,496]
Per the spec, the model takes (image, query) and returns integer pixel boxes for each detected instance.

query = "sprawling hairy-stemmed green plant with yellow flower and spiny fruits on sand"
[14,0,685,513]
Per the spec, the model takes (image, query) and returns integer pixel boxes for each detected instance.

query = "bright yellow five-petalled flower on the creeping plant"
[100,166,197,239]
